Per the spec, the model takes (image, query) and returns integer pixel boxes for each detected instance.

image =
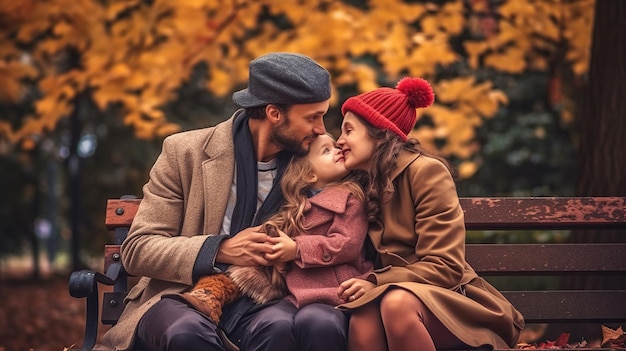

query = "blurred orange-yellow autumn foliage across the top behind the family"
[0,0,593,175]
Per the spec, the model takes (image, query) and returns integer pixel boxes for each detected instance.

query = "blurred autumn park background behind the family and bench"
[0,0,626,351]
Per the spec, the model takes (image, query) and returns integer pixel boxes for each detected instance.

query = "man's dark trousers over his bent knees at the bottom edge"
[135,299,348,351]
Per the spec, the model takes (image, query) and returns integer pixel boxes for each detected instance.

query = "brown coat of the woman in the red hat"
[340,150,524,348]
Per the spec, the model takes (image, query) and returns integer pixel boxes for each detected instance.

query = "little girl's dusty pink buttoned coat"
[285,186,373,308]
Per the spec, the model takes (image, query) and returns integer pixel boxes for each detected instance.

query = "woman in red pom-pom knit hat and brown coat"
[338,78,524,351]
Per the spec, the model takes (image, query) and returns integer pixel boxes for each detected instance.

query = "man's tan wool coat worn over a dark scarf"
[96,117,235,350]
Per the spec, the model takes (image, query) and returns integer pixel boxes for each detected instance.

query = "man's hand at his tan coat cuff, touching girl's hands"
[215,226,273,266]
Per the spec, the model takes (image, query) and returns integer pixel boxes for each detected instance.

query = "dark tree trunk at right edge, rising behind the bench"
[578,0,626,196]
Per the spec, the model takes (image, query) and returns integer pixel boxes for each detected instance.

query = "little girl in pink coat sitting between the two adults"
[266,135,373,308]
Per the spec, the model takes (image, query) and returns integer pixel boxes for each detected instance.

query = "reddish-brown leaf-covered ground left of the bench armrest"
[0,275,107,351]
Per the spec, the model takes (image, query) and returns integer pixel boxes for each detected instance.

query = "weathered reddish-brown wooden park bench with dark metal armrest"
[69,197,626,350]
